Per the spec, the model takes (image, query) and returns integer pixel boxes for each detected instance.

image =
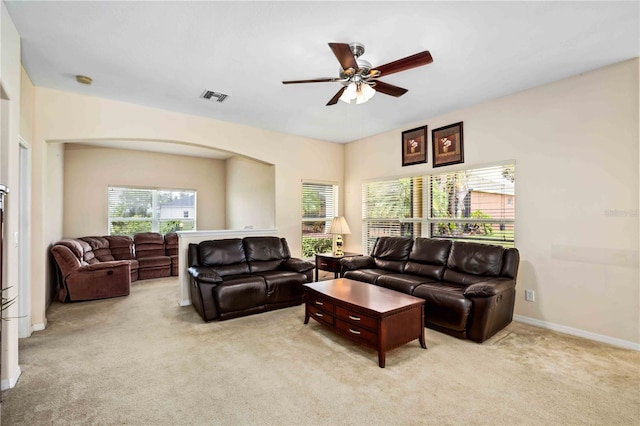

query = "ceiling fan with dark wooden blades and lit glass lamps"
[282,43,433,106]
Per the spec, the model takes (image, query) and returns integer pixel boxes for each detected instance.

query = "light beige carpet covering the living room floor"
[2,278,640,425]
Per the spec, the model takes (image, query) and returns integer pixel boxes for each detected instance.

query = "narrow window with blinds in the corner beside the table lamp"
[302,182,338,258]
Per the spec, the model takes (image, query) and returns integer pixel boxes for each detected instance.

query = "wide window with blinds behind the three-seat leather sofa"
[362,164,515,253]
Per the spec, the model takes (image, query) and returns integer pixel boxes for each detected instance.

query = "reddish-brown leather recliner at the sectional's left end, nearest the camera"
[51,239,131,302]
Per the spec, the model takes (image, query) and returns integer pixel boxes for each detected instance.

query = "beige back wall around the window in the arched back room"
[62,144,226,238]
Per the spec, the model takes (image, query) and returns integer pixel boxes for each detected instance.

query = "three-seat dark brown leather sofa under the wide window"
[340,237,520,343]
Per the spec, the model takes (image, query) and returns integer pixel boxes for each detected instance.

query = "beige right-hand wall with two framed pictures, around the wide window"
[345,59,640,347]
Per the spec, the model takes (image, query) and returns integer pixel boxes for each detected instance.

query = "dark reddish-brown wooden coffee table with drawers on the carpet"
[304,278,427,368]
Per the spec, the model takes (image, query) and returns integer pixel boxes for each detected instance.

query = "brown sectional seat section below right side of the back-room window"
[133,232,171,280]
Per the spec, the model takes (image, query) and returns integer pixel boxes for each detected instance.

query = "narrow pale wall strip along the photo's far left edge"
[0,2,21,389]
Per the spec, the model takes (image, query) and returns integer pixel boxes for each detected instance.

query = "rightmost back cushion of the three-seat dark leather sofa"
[444,241,505,284]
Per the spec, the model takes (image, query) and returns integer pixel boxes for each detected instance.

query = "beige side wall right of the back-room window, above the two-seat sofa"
[226,157,276,229]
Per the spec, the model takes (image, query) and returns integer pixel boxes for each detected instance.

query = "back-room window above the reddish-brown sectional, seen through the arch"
[107,187,196,236]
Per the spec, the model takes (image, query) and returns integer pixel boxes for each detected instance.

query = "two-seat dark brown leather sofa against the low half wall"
[188,237,315,321]
